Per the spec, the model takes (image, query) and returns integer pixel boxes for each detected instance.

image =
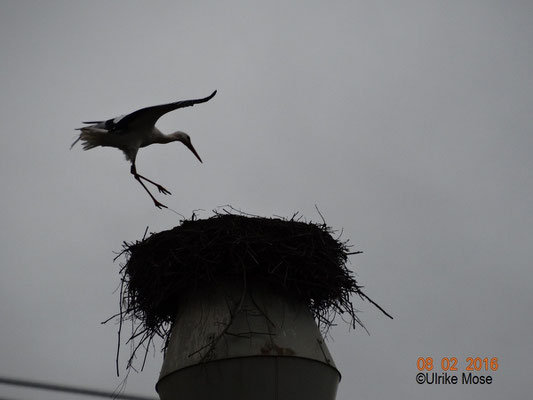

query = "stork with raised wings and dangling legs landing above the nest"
[70,90,217,208]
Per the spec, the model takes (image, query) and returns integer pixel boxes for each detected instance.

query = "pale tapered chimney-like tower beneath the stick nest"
[156,279,340,400]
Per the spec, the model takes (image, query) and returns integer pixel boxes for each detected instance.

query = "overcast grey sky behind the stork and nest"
[0,0,533,400]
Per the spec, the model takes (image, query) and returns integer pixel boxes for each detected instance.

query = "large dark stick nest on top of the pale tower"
[109,212,388,368]
